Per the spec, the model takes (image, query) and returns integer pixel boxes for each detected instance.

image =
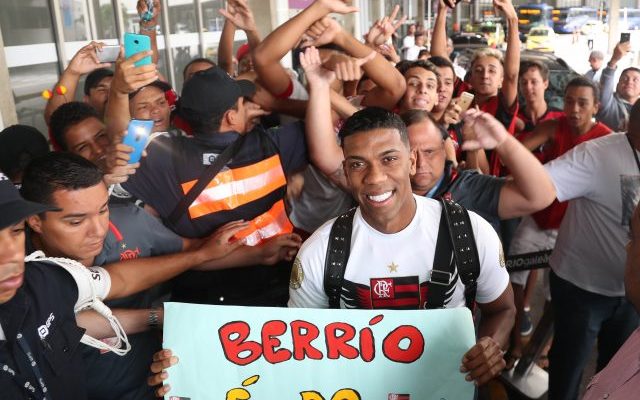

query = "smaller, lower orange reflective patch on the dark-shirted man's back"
[234,200,293,246]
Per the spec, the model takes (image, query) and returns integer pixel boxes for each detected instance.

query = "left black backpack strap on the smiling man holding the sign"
[324,207,356,308]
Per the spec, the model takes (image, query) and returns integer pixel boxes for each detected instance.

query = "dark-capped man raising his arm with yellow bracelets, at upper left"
[44,42,113,124]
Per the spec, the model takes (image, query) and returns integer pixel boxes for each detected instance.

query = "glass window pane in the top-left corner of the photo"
[0,0,54,46]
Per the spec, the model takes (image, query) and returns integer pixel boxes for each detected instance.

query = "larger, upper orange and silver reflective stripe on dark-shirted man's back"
[182,154,287,218]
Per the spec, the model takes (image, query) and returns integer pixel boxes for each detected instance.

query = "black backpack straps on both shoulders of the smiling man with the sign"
[324,199,480,312]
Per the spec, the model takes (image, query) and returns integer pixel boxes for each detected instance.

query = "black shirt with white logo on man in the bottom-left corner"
[0,262,87,400]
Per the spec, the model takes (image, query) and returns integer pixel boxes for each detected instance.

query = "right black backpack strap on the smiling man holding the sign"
[440,199,480,311]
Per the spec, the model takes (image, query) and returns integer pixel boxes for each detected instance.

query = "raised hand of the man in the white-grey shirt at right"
[462,108,509,151]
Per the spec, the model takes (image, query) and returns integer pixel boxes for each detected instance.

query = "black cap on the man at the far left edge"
[0,172,59,229]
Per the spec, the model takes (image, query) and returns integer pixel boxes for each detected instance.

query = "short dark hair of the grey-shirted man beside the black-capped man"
[20,152,102,205]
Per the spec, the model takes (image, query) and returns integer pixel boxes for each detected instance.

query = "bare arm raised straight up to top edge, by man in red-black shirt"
[493,0,520,107]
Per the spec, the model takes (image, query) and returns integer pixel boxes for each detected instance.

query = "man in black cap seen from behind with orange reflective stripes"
[123,67,307,306]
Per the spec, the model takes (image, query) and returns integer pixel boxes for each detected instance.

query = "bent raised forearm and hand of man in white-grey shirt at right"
[462,110,556,219]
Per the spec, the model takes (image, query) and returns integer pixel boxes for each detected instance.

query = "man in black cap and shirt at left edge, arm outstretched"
[0,173,244,400]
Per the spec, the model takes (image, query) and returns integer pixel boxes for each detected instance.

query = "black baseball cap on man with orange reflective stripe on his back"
[180,66,256,116]
